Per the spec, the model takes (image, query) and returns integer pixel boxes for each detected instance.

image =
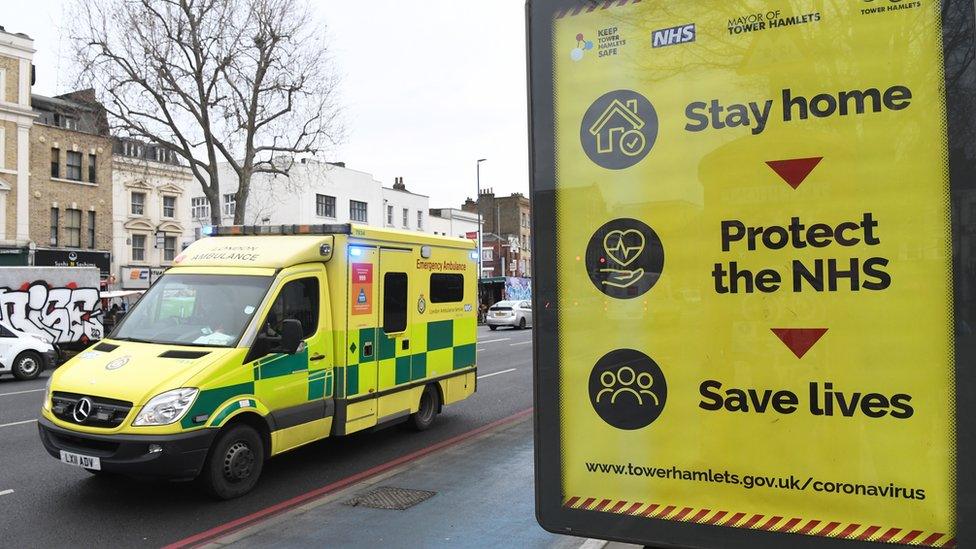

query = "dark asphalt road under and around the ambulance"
[0,327,532,547]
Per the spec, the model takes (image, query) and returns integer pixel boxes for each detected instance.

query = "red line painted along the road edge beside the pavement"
[163,408,532,549]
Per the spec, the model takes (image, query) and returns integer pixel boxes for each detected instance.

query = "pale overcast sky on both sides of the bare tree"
[0,0,528,207]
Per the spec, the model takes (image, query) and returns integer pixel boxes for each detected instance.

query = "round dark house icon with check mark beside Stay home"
[580,90,658,170]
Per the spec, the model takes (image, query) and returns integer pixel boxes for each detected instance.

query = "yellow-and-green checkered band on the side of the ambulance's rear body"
[336,317,477,398]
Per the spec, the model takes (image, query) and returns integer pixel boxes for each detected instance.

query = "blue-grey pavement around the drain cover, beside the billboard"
[200,416,634,549]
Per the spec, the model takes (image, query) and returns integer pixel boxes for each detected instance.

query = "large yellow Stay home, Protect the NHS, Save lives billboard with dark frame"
[529,0,976,547]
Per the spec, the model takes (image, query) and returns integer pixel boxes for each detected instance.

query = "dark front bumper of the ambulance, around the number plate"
[37,417,217,480]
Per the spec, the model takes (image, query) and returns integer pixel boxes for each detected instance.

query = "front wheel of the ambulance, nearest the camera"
[197,423,265,500]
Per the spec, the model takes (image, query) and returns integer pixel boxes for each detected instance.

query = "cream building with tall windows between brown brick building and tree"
[112,139,194,290]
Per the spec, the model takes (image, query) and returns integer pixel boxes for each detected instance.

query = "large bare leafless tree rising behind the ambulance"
[69,0,343,225]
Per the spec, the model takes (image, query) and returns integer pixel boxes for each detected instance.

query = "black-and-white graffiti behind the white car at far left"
[0,281,103,343]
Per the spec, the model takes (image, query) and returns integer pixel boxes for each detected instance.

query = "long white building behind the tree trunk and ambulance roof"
[190,160,430,236]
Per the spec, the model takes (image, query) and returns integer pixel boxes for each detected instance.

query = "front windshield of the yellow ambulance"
[111,274,272,347]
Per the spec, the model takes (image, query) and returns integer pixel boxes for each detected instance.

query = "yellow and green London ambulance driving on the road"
[38,224,477,499]
